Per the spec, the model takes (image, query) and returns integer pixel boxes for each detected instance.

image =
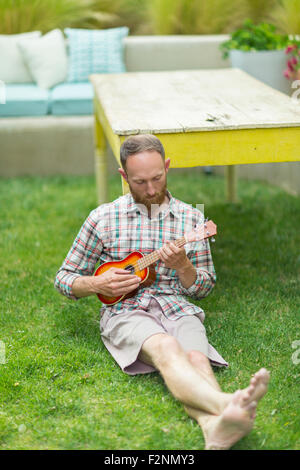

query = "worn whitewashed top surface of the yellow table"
[90,68,300,135]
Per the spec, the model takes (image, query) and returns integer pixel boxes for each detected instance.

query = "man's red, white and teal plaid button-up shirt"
[55,193,216,321]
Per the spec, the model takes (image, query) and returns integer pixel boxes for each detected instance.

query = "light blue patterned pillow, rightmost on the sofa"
[64,26,129,82]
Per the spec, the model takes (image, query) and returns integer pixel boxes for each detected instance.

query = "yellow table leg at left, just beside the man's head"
[94,116,108,204]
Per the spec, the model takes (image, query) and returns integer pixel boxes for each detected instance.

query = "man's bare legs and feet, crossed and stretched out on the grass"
[139,334,269,449]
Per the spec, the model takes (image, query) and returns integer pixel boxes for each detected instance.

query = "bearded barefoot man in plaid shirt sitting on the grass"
[55,135,269,449]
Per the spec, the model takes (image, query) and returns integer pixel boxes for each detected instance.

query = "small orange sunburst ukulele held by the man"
[94,220,217,305]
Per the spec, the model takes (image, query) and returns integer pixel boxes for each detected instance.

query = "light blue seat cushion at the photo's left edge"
[0,83,49,117]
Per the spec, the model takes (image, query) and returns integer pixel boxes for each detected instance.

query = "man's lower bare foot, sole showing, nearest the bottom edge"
[202,390,257,450]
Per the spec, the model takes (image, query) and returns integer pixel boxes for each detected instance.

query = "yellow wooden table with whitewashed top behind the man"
[90,69,300,204]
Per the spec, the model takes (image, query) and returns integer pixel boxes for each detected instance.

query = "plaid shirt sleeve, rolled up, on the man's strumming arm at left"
[54,210,103,300]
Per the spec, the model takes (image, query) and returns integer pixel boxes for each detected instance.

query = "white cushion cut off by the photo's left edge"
[0,31,41,83]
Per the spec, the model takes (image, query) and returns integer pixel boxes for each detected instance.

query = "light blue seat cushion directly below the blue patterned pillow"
[50,82,93,116]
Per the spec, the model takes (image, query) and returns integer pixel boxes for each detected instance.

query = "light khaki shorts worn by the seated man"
[100,298,228,375]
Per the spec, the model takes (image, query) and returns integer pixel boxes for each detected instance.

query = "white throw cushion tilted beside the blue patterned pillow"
[18,29,68,89]
